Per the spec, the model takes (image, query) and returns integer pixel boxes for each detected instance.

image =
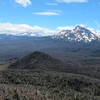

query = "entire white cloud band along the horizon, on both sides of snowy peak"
[0,23,100,36]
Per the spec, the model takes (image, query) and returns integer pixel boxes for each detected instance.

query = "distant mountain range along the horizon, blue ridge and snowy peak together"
[0,26,100,42]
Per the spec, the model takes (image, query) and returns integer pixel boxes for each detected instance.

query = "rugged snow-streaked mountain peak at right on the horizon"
[53,26,99,42]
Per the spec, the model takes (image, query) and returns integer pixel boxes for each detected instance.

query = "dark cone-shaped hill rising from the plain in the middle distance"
[9,51,64,70]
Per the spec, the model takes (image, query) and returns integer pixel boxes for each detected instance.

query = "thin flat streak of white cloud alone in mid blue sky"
[33,11,60,16]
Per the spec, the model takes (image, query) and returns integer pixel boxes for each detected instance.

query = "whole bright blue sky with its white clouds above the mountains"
[0,0,100,34]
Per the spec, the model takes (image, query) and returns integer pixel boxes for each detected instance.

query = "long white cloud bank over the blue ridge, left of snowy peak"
[0,23,54,36]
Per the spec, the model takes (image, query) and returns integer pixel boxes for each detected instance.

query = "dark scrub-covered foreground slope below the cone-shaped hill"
[0,70,100,100]
